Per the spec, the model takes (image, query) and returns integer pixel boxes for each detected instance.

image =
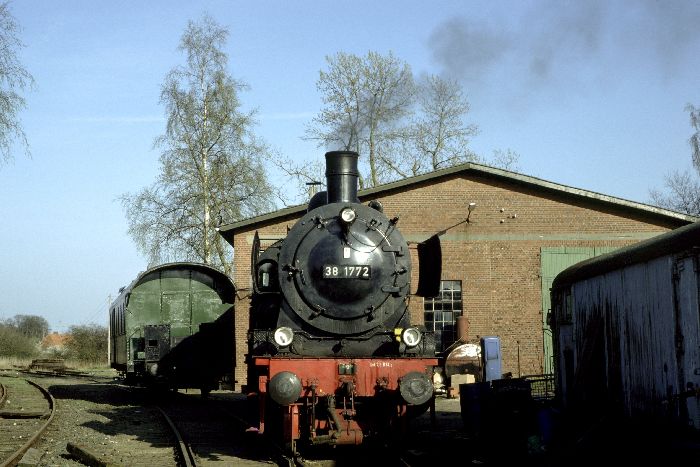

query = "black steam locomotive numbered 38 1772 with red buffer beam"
[247,151,440,454]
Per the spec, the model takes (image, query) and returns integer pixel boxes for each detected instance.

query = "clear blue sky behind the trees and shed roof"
[0,0,700,331]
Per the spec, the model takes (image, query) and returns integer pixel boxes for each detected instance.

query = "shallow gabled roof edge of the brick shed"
[219,162,700,244]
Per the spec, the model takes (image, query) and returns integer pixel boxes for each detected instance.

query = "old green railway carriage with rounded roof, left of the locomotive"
[109,262,235,394]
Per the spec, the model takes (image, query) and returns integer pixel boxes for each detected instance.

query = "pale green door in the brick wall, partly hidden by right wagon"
[540,246,616,374]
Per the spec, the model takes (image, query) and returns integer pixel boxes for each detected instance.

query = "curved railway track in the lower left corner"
[0,376,56,467]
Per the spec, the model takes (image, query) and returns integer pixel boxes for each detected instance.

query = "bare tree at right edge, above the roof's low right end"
[649,104,700,216]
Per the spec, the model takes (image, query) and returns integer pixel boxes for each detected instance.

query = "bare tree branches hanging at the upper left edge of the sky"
[0,2,34,166]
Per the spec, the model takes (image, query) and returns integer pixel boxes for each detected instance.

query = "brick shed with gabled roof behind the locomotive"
[220,163,697,390]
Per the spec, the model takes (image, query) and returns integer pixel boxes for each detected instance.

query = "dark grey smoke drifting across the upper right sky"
[428,0,700,98]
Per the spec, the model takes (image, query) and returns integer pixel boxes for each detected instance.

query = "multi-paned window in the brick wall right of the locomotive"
[423,281,462,352]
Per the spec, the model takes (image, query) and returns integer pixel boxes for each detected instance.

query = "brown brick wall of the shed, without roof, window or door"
[227,174,682,384]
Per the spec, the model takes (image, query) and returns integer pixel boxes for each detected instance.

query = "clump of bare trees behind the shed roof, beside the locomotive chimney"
[304,52,506,188]
